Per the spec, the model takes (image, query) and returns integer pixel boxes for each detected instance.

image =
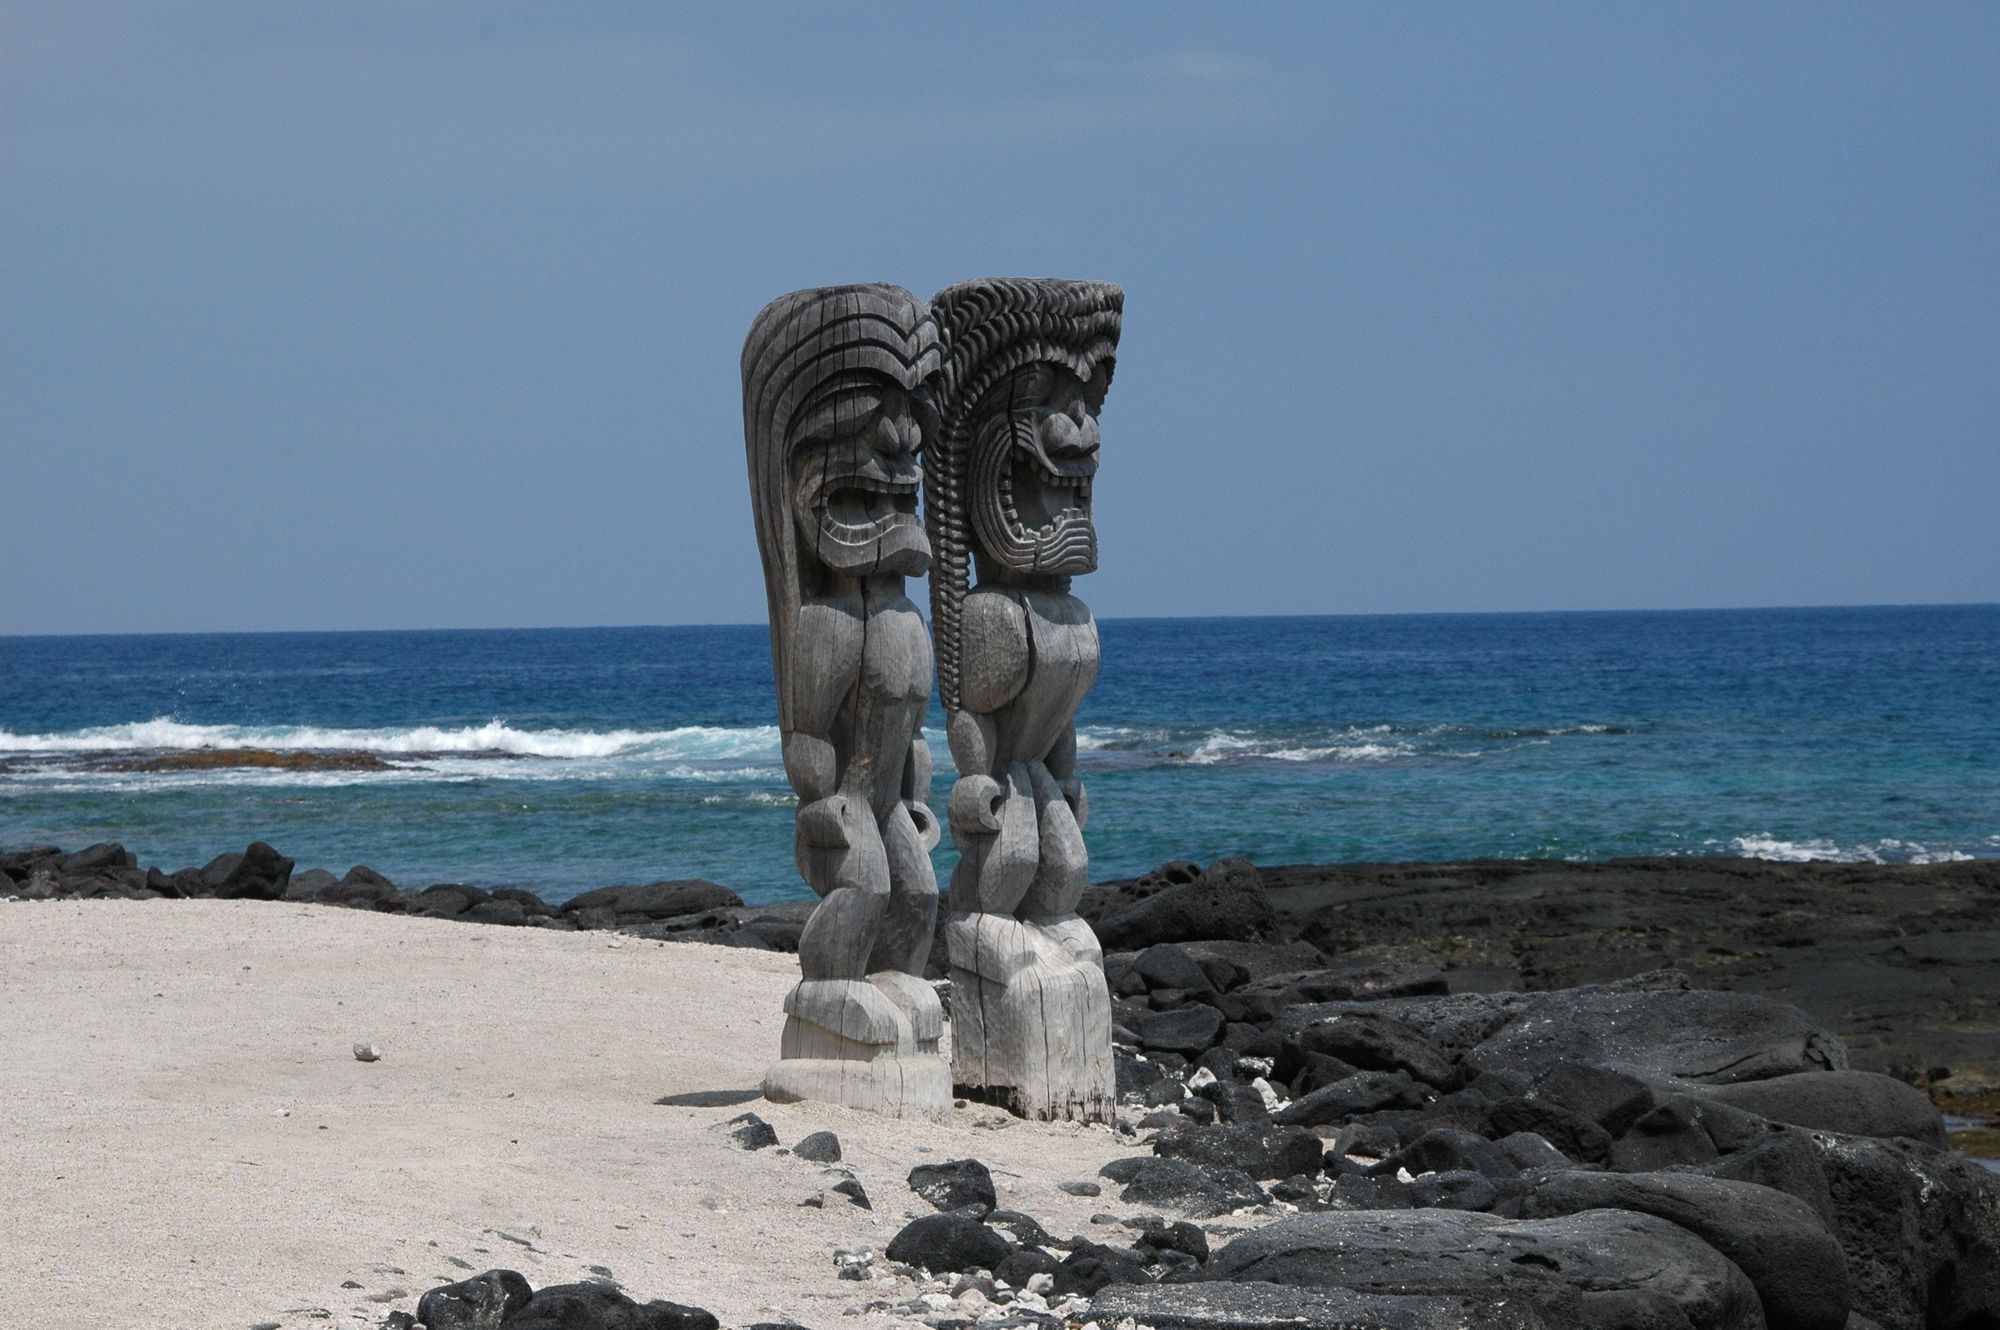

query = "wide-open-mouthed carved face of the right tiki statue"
[968,362,1104,576]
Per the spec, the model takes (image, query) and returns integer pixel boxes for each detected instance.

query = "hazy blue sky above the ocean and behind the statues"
[0,0,2000,632]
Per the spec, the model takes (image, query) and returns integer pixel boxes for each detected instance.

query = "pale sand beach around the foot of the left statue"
[0,900,1132,1330]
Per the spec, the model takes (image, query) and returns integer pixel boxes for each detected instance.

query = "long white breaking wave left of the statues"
[0,716,778,760]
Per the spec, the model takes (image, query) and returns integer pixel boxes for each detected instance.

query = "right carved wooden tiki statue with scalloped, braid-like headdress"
[924,280,1124,1122]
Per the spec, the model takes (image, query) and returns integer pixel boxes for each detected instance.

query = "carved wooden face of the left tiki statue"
[790,374,930,578]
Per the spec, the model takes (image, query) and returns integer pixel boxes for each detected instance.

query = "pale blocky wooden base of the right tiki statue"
[944,914,1118,1122]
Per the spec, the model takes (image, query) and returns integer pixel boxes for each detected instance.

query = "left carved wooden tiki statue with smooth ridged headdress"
[742,286,952,1116]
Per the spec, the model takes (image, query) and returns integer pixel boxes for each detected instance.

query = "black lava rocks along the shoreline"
[0,846,2000,1330]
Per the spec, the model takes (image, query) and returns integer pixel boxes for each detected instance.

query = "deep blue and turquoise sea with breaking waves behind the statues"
[0,606,2000,902]
